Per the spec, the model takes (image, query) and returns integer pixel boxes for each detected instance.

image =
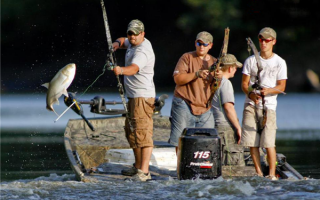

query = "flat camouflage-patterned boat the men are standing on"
[64,93,304,182]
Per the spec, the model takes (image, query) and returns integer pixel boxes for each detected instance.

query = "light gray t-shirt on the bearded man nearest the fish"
[124,38,156,98]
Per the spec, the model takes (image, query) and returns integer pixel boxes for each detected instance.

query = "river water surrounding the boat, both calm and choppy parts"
[0,93,320,199]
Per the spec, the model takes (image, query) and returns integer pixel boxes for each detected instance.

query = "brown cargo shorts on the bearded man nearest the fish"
[125,97,155,148]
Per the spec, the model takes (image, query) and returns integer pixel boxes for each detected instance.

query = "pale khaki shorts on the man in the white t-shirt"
[241,104,277,148]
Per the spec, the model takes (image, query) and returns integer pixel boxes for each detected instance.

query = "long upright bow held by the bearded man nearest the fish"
[101,0,133,131]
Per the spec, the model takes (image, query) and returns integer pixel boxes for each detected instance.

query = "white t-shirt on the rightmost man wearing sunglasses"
[242,54,288,110]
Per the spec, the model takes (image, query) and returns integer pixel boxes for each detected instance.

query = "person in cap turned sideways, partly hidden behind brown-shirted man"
[212,54,245,166]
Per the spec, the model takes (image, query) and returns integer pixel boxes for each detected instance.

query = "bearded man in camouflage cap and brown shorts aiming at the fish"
[113,19,156,181]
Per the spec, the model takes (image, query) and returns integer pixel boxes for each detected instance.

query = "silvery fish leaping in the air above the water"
[42,63,76,115]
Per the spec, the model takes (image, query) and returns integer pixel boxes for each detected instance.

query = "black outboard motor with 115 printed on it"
[177,128,222,180]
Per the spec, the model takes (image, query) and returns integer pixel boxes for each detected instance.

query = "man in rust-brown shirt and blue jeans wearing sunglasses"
[168,31,217,151]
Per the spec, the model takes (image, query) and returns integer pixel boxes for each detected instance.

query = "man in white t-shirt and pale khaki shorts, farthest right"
[241,27,287,180]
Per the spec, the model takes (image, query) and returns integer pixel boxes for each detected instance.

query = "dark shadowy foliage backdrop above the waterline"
[1,0,320,93]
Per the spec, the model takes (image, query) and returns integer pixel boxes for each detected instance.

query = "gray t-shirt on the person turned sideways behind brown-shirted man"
[212,77,234,126]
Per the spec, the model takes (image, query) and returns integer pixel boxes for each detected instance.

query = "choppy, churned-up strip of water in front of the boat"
[1,174,320,199]
